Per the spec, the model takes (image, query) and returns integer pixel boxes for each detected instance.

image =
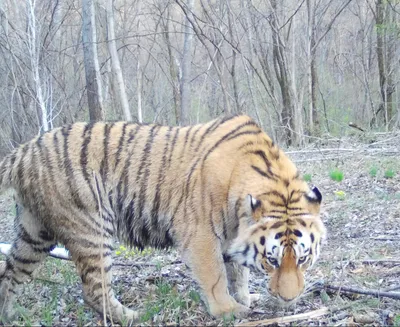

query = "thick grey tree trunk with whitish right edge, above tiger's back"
[82,0,104,121]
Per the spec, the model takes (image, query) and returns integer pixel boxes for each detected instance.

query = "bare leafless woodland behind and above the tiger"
[0,0,400,154]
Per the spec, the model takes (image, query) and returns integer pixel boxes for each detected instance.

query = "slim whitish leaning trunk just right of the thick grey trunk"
[107,0,132,121]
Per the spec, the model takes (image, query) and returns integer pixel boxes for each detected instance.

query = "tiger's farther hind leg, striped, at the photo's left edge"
[0,206,55,321]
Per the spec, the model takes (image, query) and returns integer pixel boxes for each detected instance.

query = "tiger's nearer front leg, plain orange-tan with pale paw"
[183,229,249,317]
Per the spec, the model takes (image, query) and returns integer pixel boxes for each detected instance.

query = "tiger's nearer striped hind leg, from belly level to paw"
[66,237,139,324]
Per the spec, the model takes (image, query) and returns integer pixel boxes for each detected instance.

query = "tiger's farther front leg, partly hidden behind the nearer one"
[225,262,260,307]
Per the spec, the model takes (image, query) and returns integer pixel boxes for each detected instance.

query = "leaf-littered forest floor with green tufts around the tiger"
[0,134,400,326]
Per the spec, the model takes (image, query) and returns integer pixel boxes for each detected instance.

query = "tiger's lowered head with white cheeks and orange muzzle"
[227,187,325,305]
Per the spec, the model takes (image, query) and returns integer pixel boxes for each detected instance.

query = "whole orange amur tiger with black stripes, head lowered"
[0,116,325,322]
